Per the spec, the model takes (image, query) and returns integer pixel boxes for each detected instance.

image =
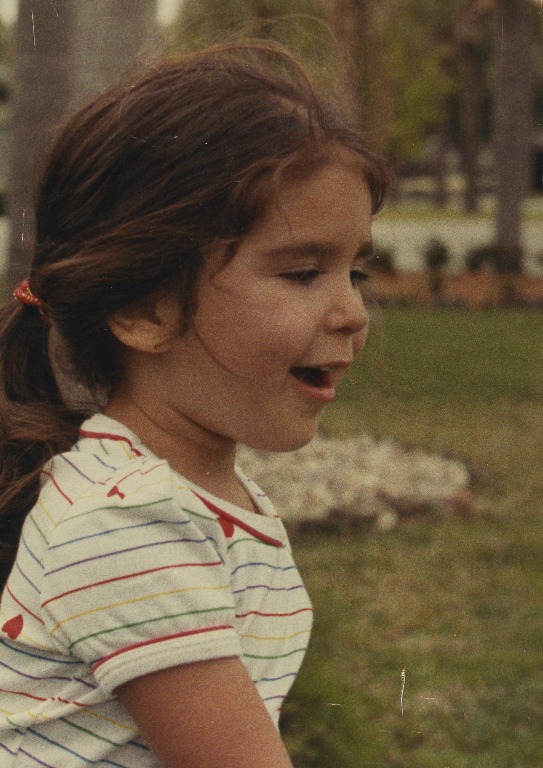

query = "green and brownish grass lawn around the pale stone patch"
[284,309,543,768]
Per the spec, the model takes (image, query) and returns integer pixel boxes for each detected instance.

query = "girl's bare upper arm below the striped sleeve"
[116,657,292,768]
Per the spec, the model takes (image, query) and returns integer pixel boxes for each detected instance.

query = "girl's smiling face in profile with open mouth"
[162,160,371,451]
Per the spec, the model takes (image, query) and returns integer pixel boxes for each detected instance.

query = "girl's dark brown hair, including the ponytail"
[0,43,387,577]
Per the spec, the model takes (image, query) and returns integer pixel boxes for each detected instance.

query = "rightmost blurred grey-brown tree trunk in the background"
[494,0,534,272]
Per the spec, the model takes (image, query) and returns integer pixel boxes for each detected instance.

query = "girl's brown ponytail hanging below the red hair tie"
[0,301,84,588]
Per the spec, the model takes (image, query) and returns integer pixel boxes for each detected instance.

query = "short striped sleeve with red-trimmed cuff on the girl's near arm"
[42,460,241,692]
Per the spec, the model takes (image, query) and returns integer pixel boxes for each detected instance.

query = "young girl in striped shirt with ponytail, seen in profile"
[0,45,392,768]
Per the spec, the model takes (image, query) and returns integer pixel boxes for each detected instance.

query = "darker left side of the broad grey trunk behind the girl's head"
[7,0,73,295]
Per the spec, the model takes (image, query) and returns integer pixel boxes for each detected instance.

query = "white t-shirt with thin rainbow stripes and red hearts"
[0,415,312,768]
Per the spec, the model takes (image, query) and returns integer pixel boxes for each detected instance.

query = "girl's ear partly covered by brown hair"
[108,293,181,354]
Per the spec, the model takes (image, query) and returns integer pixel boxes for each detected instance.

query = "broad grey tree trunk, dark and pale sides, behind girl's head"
[7,0,156,291]
